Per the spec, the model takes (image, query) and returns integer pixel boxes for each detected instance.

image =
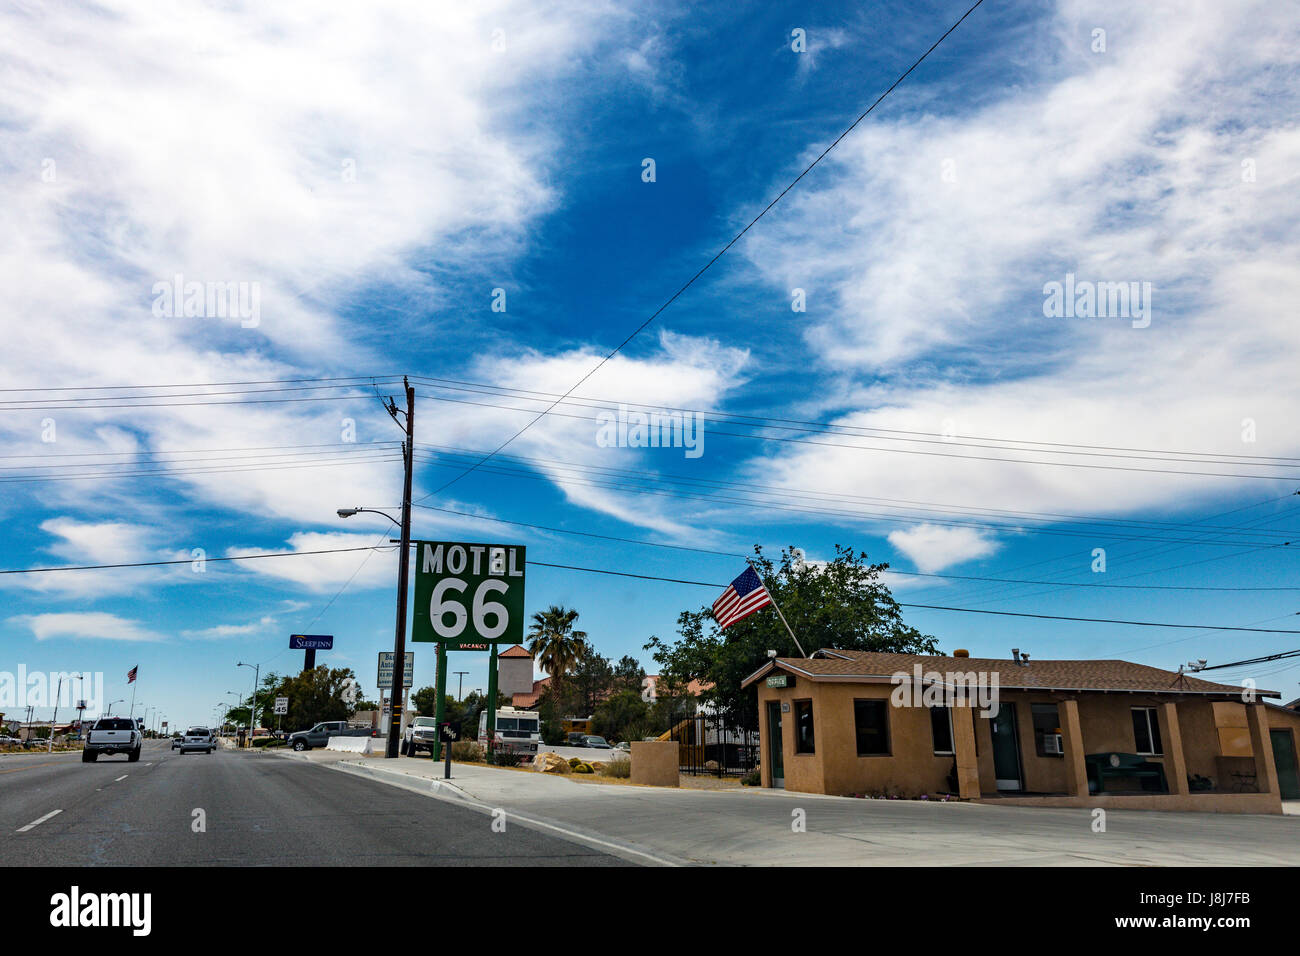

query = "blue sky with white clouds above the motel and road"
[0,0,1300,724]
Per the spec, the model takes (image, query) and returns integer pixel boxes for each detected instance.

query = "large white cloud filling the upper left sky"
[0,0,628,530]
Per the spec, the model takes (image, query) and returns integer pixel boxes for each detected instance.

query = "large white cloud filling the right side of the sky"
[746,1,1300,535]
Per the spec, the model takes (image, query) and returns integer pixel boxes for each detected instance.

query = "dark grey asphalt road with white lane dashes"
[0,740,627,866]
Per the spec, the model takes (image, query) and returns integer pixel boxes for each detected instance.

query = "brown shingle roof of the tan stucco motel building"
[741,649,1282,697]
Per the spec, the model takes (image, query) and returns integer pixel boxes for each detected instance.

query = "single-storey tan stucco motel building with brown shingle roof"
[742,649,1300,813]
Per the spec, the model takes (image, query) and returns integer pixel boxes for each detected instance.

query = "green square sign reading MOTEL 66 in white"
[411,541,524,650]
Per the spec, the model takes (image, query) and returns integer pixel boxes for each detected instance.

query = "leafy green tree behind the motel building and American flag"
[645,545,937,723]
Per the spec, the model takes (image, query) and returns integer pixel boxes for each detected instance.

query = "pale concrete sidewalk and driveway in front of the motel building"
[269,750,1300,866]
